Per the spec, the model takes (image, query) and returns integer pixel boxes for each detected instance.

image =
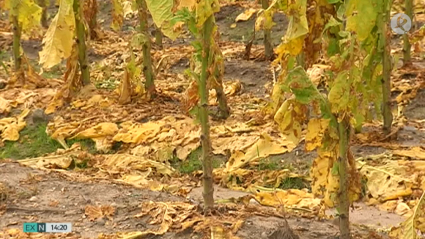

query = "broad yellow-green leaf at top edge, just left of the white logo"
[346,0,382,41]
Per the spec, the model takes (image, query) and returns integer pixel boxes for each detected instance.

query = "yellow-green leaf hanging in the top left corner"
[4,0,41,32]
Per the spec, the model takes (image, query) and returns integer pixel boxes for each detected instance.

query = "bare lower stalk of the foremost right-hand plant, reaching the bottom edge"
[338,119,350,239]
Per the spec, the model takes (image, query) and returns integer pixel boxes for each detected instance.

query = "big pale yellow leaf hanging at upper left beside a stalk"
[39,0,75,68]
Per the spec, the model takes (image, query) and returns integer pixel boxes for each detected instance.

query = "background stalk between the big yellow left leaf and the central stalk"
[137,0,155,96]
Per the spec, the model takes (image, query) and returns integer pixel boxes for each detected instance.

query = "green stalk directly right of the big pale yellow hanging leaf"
[73,0,90,85]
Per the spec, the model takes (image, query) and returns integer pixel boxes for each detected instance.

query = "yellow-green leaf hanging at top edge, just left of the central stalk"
[146,0,178,40]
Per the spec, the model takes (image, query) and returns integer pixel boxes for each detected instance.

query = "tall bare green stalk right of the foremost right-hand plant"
[378,0,393,134]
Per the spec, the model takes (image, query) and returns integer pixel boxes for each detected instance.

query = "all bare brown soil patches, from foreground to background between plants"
[0,0,425,239]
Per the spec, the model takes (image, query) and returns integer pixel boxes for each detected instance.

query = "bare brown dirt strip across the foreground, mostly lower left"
[0,162,394,239]
